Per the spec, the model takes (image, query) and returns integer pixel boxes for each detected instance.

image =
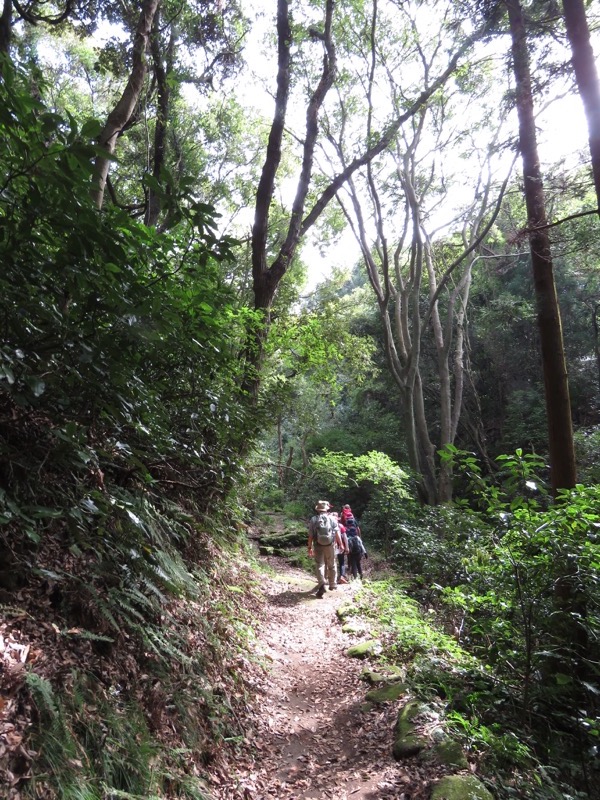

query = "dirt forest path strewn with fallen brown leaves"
[211,558,430,800]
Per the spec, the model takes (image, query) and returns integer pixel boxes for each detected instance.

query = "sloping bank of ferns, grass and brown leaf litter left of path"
[8,501,259,800]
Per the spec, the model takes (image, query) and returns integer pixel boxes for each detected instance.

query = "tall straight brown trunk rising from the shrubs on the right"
[505,0,577,494]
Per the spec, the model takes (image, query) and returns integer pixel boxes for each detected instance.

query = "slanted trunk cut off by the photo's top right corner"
[563,0,600,215]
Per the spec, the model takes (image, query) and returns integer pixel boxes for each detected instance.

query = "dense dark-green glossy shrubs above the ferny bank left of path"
[0,59,250,538]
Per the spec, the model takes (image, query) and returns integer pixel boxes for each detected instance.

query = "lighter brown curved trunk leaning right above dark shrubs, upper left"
[92,0,160,208]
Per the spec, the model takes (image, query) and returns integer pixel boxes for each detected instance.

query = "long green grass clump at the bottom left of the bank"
[27,671,207,800]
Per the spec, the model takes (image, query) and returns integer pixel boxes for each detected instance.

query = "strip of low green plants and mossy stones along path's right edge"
[350,578,587,800]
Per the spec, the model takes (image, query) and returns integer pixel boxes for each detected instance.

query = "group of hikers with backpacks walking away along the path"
[308,500,367,598]
